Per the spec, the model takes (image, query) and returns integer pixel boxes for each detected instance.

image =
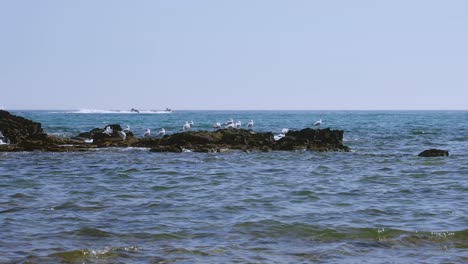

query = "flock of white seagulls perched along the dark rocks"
[93,118,322,143]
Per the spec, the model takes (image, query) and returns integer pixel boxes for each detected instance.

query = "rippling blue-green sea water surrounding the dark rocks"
[0,111,468,263]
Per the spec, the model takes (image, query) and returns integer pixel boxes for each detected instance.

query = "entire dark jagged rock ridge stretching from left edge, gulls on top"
[0,111,349,152]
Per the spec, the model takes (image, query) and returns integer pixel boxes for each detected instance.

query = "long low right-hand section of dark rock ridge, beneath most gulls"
[140,128,349,152]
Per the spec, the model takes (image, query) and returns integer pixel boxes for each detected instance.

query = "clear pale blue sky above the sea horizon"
[0,0,468,110]
